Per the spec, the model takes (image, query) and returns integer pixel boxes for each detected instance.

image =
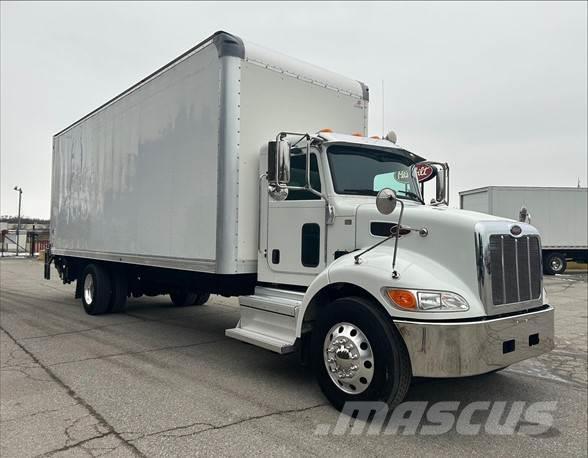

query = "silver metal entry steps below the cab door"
[225,287,304,354]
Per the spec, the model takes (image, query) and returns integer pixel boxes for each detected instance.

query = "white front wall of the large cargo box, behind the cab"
[238,60,368,263]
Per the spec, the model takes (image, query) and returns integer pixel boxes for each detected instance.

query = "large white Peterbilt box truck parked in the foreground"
[45,32,554,409]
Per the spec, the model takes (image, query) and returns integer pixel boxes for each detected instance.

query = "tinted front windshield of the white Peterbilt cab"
[327,145,422,202]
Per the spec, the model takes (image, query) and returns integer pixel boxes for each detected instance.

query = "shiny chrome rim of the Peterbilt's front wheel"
[323,323,374,394]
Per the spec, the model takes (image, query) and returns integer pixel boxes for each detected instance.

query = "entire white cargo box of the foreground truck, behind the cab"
[51,32,368,274]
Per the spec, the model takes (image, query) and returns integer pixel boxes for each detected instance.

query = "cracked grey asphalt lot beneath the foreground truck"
[0,259,588,457]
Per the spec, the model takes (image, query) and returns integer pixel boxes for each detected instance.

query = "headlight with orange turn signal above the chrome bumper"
[384,288,470,312]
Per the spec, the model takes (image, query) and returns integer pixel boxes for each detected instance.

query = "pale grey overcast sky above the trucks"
[0,2,588,217]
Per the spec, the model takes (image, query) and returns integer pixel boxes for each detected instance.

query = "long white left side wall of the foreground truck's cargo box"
[51,45,220,271]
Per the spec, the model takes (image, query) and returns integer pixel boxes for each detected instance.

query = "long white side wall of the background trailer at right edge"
[493,188,588,248]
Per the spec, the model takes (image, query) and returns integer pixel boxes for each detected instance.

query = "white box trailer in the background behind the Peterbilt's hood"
[459,186,588,275]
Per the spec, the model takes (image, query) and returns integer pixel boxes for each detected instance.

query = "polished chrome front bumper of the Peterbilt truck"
[394,306,554,377]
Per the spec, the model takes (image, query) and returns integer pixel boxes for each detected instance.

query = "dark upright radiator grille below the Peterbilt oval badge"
[489,234,541,305]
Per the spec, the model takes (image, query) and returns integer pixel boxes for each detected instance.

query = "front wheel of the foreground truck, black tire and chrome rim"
[311,297,412,410]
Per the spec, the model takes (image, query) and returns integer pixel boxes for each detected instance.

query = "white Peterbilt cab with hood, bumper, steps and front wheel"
[227,130,553,407]
